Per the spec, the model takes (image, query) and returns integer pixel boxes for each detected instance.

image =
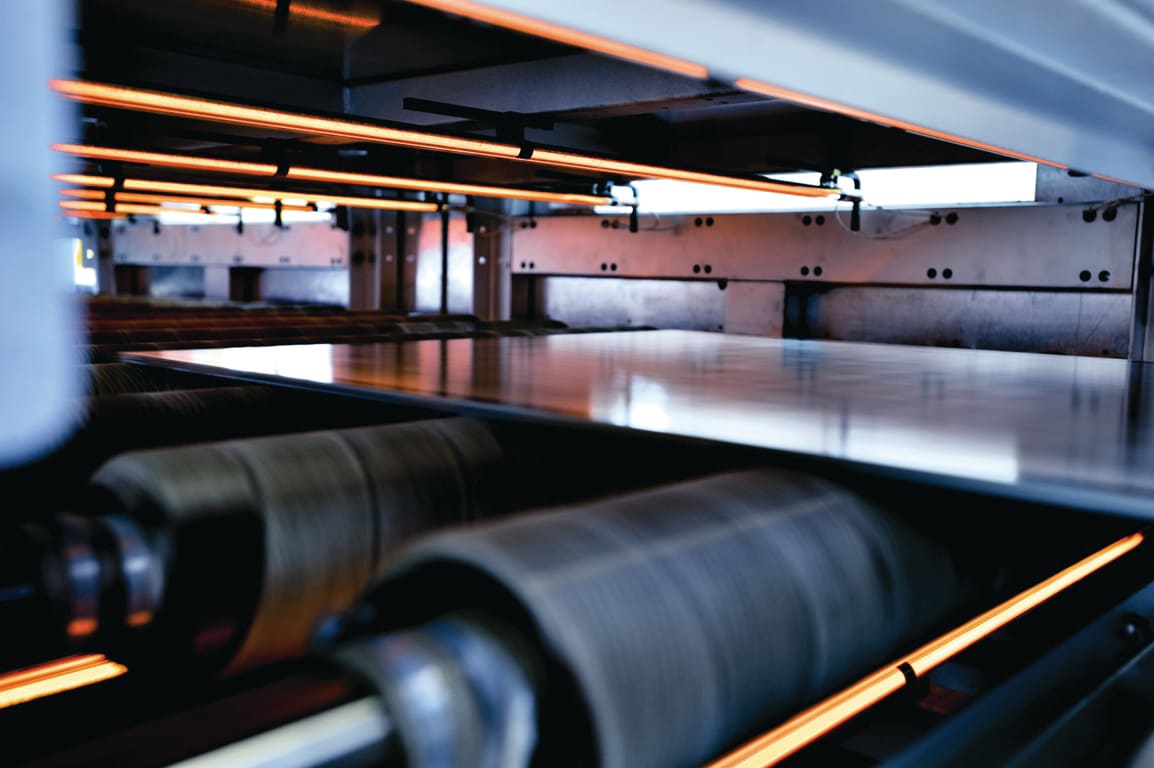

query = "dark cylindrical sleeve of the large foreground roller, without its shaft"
[350,470,960,768]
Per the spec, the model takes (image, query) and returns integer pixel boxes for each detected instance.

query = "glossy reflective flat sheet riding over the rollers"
[129,331,1154,517]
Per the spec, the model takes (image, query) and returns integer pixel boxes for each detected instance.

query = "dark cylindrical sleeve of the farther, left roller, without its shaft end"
[88,419,523,671]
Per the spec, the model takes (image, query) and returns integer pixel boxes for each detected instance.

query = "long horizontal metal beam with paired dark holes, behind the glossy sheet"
[512,205,1138,292]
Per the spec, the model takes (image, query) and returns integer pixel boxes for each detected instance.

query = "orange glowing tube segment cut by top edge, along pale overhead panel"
[409,0,710,80]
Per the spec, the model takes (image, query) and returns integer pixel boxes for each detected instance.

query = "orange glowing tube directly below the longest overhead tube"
[52,138,613,205]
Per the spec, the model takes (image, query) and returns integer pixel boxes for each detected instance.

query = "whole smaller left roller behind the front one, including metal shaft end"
[0,417,704,675]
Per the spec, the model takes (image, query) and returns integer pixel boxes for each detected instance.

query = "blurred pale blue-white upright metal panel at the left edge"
[0,0,82,467]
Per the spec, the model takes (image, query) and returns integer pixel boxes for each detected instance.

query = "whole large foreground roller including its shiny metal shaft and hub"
[0,465,1010,768]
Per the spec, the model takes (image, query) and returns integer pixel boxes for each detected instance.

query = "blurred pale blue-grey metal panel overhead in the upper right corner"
[443,0,1154,187]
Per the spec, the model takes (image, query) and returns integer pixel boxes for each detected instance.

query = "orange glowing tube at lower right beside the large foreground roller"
[709,533,1145,768]
